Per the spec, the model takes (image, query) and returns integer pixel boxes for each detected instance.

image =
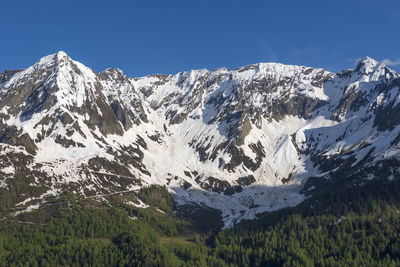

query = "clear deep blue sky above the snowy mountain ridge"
[0,0,400,77]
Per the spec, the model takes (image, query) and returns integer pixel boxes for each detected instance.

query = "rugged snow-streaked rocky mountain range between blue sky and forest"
[0,52,400,226]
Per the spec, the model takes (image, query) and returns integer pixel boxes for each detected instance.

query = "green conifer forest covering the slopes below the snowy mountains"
[0,179,400,266]
